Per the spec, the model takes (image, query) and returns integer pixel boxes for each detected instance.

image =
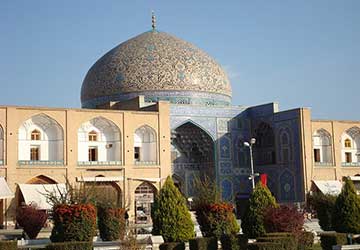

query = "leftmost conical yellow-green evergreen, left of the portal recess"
[151,177,194,242]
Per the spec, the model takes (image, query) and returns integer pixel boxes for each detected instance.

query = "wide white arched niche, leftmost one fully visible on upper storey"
[18,113,64,165]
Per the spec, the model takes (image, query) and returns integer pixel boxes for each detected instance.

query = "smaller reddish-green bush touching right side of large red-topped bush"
[97,205,125,241]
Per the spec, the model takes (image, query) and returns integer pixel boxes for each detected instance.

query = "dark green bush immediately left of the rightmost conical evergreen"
[309,193,336,231]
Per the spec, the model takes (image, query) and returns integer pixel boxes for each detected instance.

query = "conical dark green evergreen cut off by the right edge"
[332,179,360,234]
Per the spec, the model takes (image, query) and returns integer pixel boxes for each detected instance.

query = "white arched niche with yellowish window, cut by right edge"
[340,127,360,166]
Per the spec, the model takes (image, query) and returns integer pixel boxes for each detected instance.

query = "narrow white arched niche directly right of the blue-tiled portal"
[312,128,333,165]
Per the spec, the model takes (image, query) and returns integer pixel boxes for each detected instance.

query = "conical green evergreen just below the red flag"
[241,182,277,238]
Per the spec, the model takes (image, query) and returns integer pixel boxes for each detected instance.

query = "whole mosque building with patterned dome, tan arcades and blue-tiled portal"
[0,16,360,226]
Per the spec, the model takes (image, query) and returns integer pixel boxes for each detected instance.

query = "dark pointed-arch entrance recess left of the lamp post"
[171,122,215,197]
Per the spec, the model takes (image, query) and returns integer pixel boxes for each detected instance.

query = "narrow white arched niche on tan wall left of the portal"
[134,125,157,165]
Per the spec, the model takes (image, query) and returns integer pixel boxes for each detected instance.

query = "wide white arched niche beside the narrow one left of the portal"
[78,116,122,166]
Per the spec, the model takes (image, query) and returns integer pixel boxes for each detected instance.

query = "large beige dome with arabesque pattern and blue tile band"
[81,29,231,108]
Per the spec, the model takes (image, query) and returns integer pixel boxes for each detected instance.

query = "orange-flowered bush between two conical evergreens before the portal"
[196,202,240,239]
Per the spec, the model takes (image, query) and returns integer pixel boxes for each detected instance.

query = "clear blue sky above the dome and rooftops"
[0,0,360,120]
